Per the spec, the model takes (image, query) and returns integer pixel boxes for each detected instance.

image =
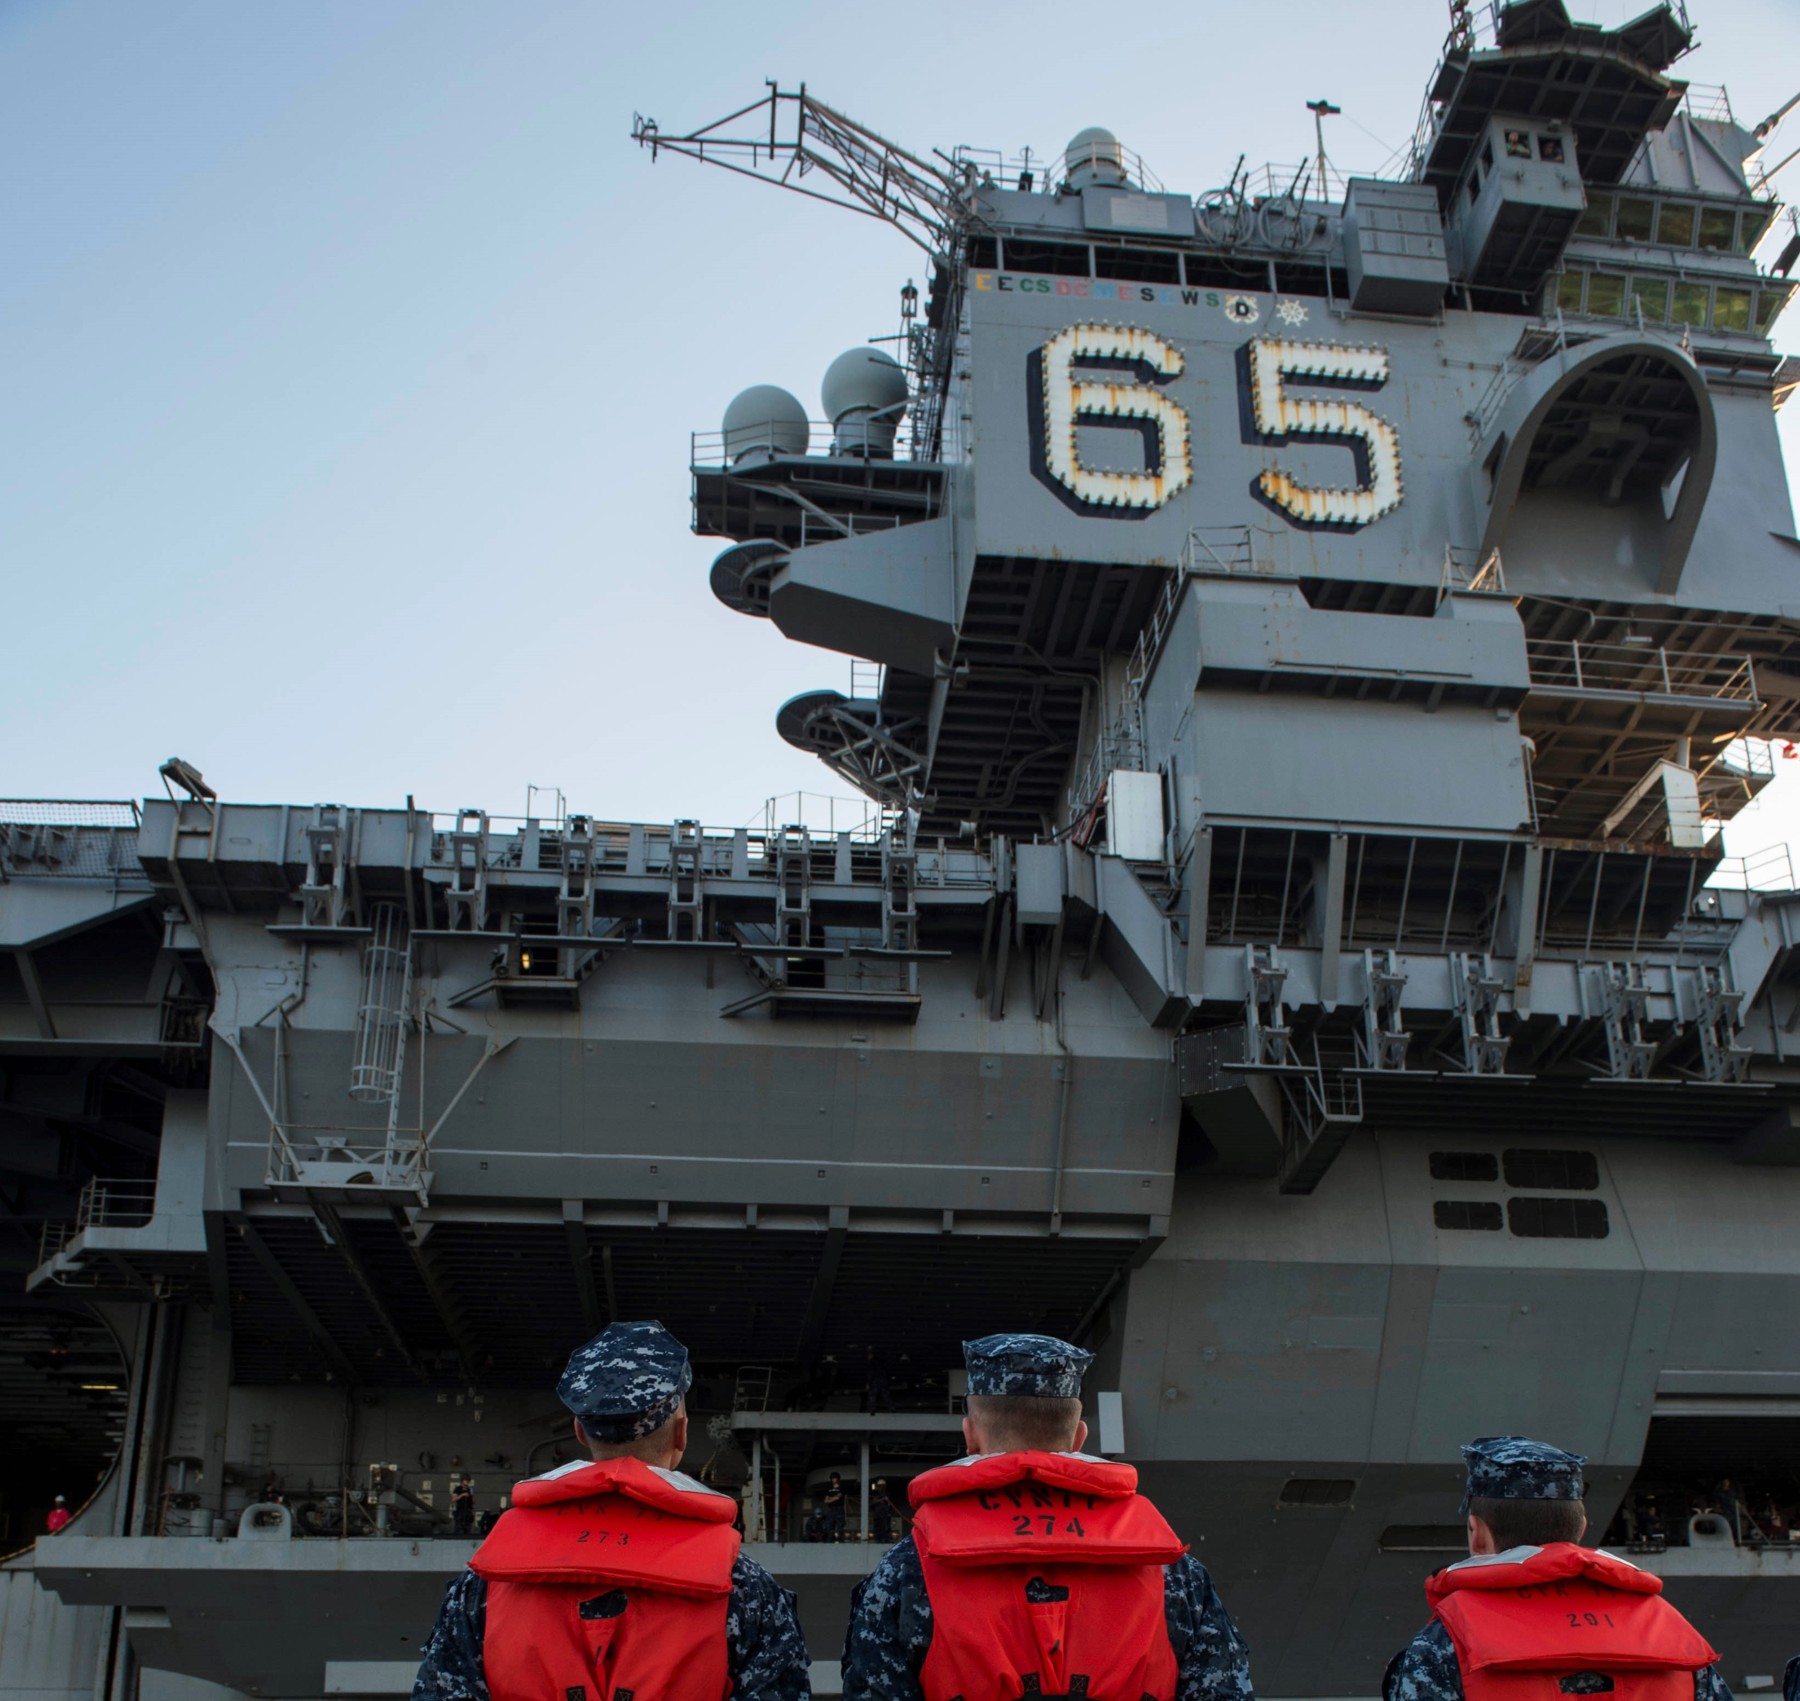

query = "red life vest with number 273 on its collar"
[470,1458,738,1701]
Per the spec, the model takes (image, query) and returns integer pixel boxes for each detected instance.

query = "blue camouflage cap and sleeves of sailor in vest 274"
[844,1334,1255,1701]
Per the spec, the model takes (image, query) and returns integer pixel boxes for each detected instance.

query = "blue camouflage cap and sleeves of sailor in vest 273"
[412,1323,812,1701]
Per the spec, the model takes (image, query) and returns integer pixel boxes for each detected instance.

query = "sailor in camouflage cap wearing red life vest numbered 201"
[1382,1435,1732,1701]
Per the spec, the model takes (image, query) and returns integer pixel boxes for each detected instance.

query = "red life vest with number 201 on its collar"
[1426,1541,1719,1701]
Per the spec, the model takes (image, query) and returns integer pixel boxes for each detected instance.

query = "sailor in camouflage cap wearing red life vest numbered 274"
[842,1334,1253,1701]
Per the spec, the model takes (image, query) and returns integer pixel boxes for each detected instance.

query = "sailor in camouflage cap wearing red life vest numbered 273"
[412,1323,810,1701]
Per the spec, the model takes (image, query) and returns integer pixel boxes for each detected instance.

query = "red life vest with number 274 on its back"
[911,1453,1184,1701]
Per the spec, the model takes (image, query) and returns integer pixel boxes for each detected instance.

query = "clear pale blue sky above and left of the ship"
[0,0,1800,824]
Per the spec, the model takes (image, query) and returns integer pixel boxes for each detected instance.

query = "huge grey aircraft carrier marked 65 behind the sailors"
[0,0,1800,1697]
